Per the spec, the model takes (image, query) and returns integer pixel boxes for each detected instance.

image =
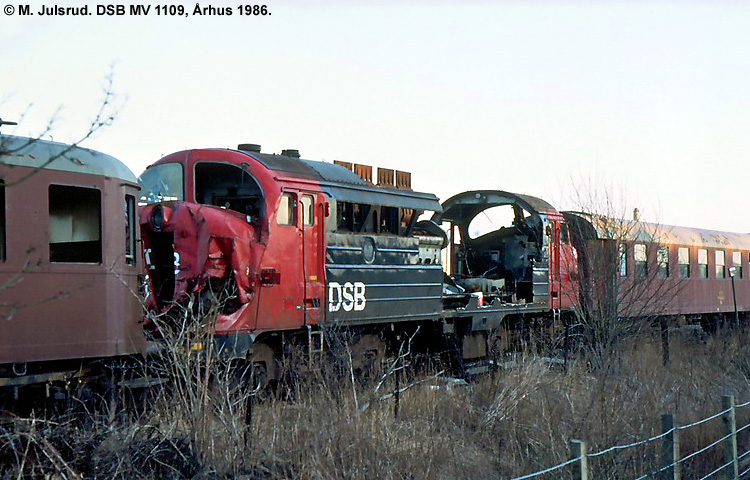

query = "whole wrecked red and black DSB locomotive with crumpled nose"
[140,145,574,378]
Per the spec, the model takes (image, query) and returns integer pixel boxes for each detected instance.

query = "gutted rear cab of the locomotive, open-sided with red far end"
[433,190,578,310]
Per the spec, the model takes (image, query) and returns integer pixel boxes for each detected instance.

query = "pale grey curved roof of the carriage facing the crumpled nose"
[0,135,137,183]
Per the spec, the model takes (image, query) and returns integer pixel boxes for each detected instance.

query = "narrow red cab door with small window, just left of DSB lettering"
[298,191,325,324]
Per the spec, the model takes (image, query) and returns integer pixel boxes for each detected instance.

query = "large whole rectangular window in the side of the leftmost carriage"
[49,185,102,263]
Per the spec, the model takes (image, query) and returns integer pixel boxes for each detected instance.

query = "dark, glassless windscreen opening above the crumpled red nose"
[194,162,263,217]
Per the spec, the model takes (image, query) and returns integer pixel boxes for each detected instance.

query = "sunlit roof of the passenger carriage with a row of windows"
[565,212,750,250]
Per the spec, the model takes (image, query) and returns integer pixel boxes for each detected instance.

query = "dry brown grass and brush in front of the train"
[0,333,750,479]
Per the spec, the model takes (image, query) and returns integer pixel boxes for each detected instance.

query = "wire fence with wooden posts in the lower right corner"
[511,395,750,480]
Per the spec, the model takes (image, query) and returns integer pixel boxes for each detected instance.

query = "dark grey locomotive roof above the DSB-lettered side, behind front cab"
[239,150,441,212]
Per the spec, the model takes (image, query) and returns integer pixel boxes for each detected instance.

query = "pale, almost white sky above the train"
[0,0,750,232]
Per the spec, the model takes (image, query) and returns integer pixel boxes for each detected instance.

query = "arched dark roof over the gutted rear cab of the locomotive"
[440,190,557,221]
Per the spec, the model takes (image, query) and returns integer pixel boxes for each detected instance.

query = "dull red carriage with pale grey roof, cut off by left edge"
[0,135,145,386]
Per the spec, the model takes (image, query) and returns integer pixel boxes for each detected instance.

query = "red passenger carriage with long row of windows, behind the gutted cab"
[564,212,750,324]
